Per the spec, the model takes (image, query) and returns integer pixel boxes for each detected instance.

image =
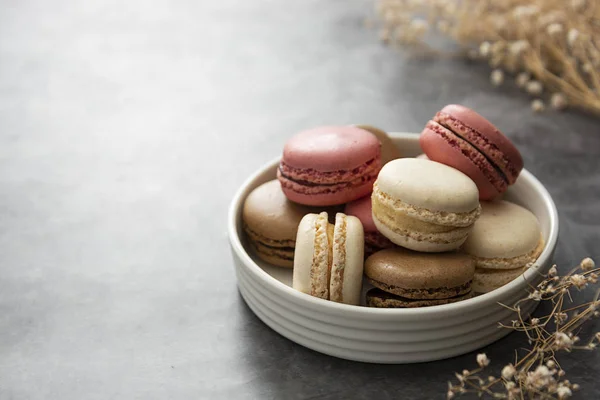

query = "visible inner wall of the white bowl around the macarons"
[231,133,558,307]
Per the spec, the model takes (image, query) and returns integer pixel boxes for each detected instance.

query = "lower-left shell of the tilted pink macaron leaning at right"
[419,121,508,200]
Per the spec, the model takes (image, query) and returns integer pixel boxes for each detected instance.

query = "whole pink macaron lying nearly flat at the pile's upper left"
[277,126,381,206]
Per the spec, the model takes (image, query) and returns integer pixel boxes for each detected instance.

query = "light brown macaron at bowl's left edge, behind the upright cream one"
[242,179,318,268]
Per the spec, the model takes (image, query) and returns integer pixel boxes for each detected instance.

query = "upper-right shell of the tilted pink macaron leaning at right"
[434,104,523,184]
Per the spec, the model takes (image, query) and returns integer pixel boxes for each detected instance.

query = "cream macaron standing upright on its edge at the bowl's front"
[292,212,364,305]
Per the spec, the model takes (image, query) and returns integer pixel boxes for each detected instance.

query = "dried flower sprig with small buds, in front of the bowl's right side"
[447,258,600,399]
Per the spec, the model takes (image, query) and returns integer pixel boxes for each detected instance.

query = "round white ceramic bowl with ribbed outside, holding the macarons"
[228,133,558,363]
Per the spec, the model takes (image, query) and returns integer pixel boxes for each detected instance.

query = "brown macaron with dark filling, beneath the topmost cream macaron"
[364,248,475,307]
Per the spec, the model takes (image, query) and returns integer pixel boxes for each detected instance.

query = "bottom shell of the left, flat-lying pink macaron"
[277,171,376,206]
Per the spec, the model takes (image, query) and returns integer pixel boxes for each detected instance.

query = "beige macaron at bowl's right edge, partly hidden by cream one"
[462,201,544,293]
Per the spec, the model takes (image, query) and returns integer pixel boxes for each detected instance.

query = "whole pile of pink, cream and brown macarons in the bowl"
[243,105,544,308]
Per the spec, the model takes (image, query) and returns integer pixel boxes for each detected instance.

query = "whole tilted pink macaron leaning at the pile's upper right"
[419,104,523,200]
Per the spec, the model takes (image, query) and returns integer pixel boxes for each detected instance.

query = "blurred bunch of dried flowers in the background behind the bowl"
[377,0,600,114]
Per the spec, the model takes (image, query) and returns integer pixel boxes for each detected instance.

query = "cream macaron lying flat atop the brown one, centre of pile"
[371,158,481,252]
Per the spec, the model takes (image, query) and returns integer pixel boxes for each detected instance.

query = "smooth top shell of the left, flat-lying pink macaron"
[282,126,381,172]
